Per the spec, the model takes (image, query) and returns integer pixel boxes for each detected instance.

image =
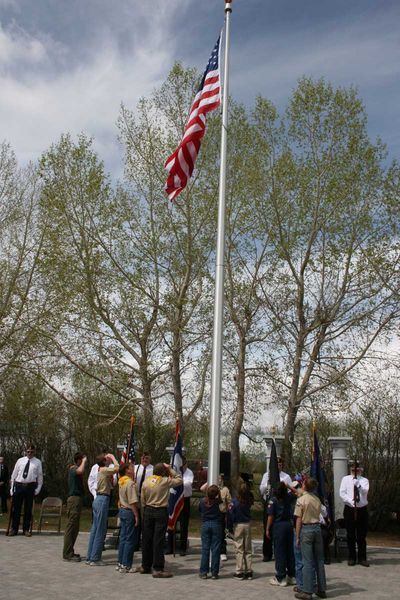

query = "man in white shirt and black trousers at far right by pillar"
[339,463,369,567]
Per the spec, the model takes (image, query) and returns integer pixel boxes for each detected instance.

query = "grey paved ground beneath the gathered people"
[0,532,400,600]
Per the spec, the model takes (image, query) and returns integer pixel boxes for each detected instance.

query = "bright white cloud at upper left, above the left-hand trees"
[0,0,188,172]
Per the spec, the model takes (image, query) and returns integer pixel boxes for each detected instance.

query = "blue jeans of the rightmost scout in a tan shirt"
[300,525,326,594]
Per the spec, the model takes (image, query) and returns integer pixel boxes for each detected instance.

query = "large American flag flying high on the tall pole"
[165,36,221,200]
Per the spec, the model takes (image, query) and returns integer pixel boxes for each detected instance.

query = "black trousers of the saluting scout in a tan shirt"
[142,506,168,571]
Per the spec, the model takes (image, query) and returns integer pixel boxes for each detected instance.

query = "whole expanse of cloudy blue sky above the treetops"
[0,0,400,175]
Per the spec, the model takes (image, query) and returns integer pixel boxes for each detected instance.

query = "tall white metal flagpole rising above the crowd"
[207,0,232,485]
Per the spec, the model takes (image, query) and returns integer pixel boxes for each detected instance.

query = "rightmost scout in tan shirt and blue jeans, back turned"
[294,479,326,600]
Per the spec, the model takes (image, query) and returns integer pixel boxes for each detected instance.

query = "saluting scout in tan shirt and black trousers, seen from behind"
[140,463,182,577]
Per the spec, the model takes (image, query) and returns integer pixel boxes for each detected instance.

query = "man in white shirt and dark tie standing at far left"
[8,444,43,537]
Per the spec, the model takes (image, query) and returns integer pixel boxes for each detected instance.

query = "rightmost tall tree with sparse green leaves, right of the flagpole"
[254,78,399,463]
